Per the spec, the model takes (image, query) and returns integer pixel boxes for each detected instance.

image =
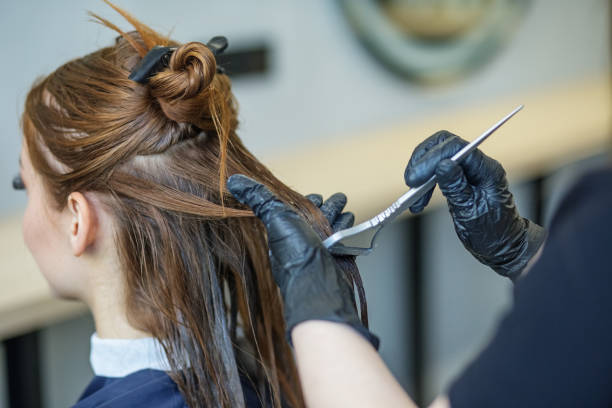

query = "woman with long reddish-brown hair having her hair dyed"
[15,3,368,407]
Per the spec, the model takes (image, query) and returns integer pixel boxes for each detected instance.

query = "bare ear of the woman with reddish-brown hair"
[68,192,98,256]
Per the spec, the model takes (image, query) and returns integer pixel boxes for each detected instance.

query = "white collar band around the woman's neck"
[89,333,170,377]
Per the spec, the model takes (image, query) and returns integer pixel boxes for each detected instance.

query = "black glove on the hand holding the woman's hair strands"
[227,174,378,348]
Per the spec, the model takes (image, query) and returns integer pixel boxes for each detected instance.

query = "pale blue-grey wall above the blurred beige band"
[0,0,609,211]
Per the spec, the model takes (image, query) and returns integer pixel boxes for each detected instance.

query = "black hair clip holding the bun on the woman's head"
[128,36,228,85]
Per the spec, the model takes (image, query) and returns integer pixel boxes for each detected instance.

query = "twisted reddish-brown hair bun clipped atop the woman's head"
[149,42,217,123]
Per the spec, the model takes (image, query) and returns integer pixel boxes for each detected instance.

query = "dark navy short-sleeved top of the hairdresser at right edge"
[449,164,612,408]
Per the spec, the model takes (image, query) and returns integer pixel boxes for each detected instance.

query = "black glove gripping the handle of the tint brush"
[404,131,546,280]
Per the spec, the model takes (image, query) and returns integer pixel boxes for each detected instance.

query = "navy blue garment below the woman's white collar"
[73,369,261,408]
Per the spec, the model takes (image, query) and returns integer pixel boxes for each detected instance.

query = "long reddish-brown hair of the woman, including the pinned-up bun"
[22,3,367,407]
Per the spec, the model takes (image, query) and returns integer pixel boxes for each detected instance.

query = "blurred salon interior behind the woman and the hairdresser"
[0,0,612,408]
